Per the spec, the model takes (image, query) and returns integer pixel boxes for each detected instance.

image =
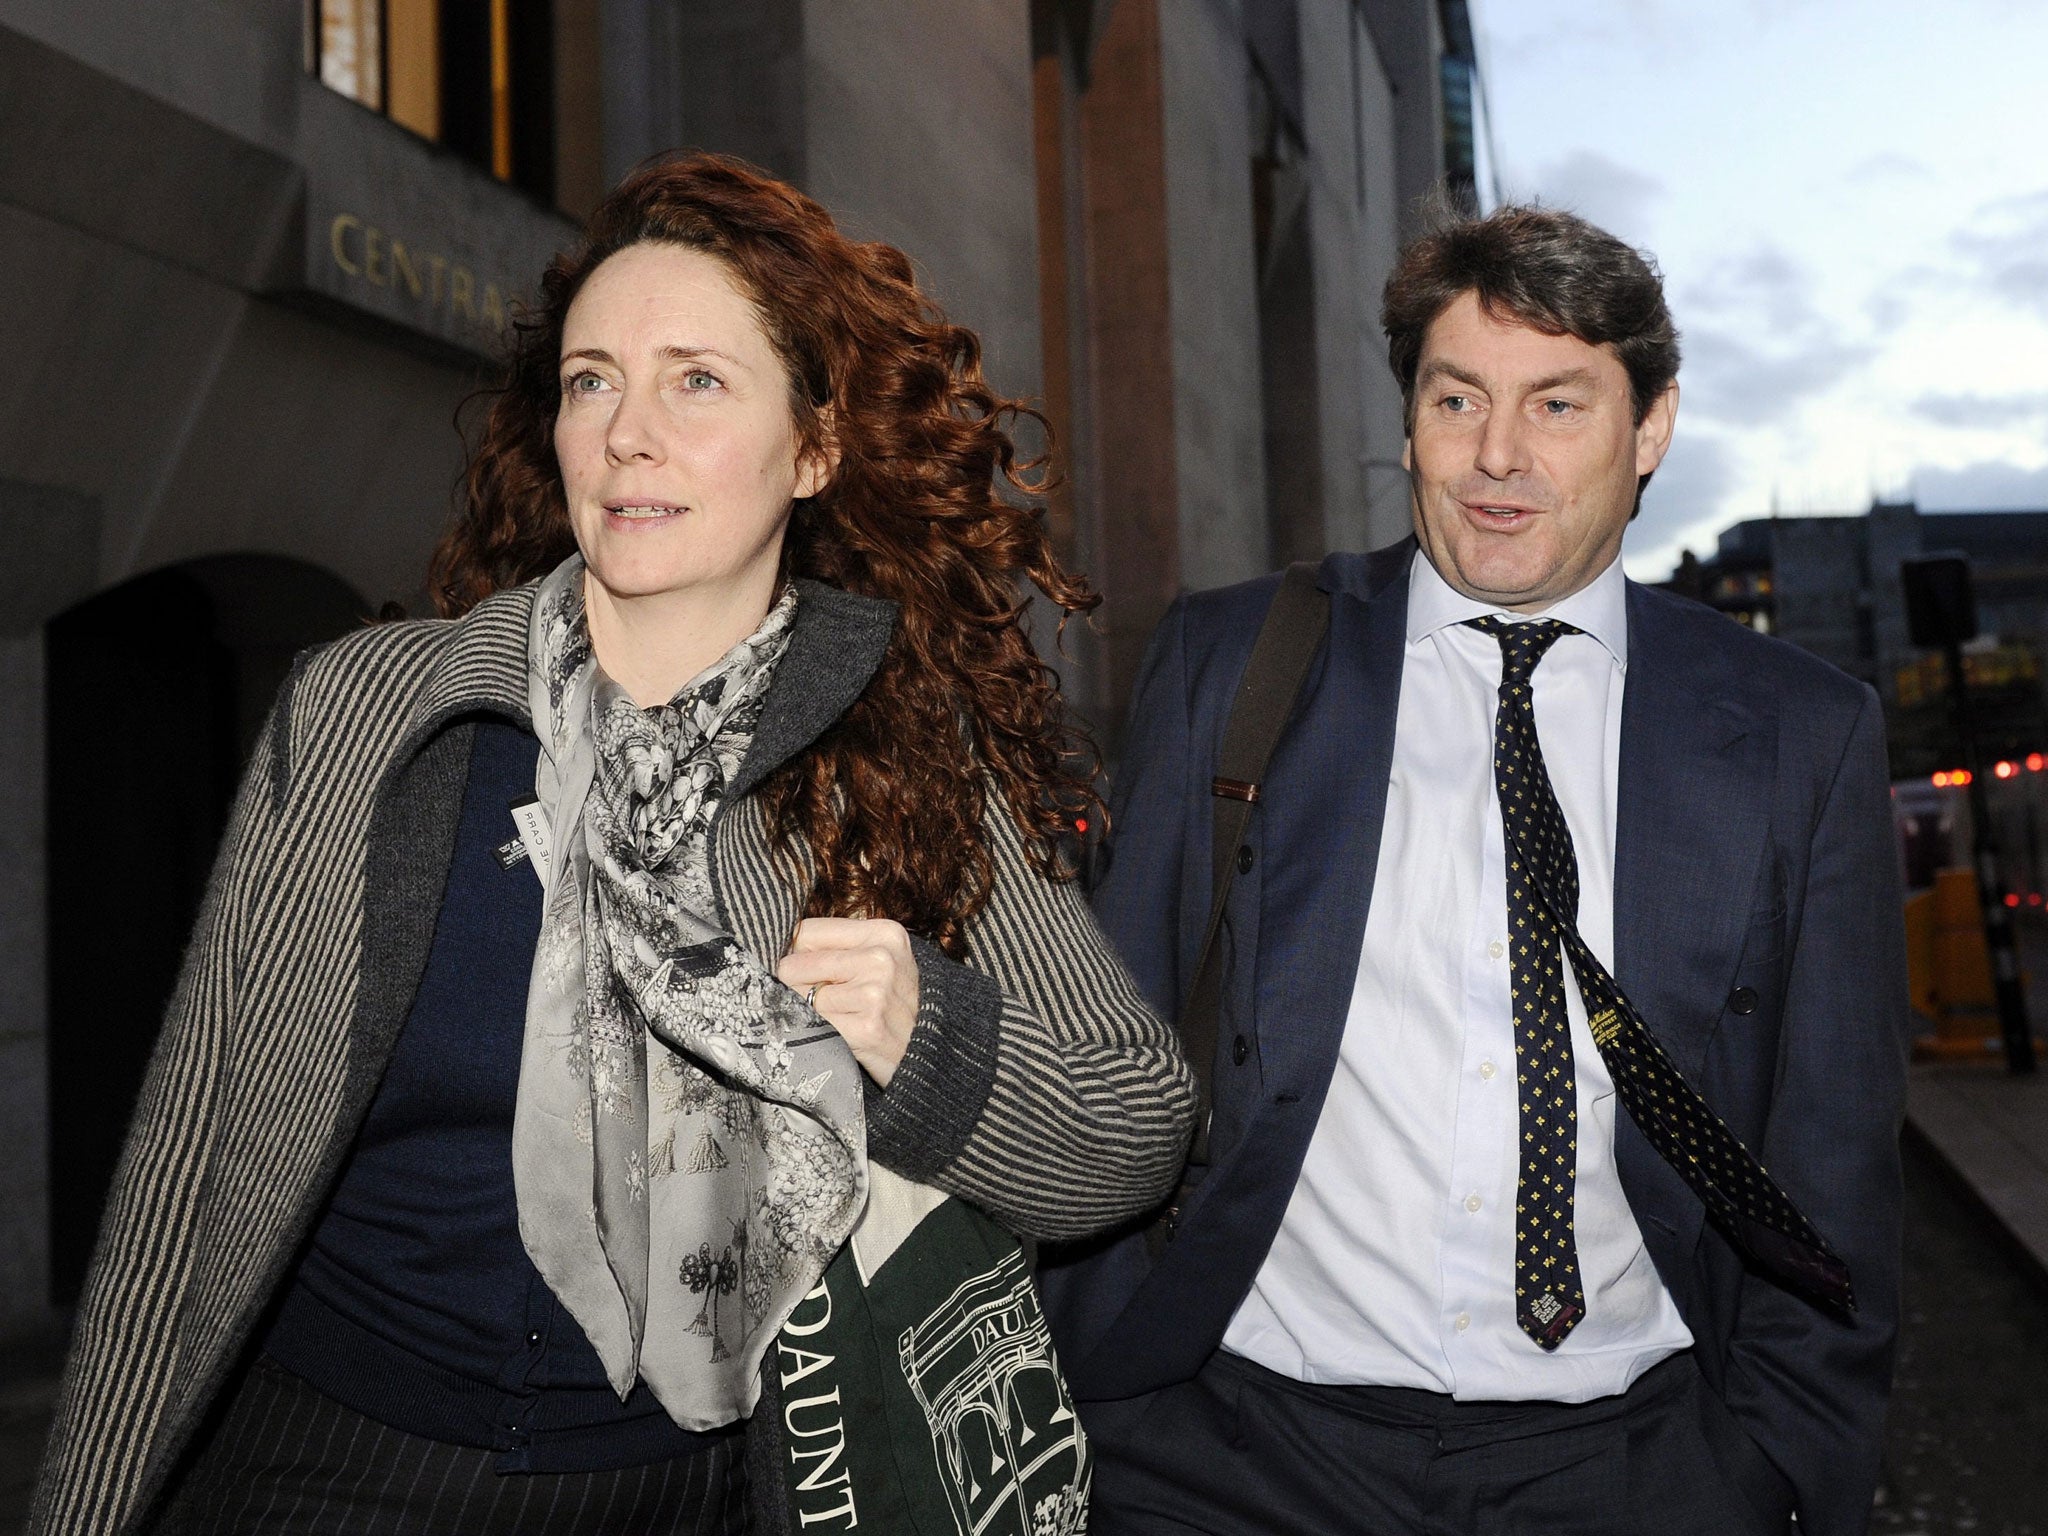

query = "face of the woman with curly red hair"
[555,242,823,602]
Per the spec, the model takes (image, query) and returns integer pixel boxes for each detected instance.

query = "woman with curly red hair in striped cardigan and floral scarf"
[31,156,1192,1534]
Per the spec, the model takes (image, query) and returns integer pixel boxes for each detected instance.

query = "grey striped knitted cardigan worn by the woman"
[29,584,1194,1536]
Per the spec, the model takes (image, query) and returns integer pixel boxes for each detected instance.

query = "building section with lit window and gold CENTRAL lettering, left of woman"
[0,0,585,1368]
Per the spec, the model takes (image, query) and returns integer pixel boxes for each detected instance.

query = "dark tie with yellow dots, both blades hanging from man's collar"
[1468,616,1855,1350]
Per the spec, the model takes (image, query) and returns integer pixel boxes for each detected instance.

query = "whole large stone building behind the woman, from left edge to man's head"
[0,0,1483,1341]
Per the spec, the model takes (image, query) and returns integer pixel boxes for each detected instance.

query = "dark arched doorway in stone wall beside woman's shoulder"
[45,555,367,1307]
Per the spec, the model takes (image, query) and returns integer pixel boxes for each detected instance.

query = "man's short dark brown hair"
[1380,203,1677,426]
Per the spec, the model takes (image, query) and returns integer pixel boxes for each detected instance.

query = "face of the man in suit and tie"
[1403,293,1677,612]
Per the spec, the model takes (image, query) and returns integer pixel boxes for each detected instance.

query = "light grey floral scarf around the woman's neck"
[512,555,868,1430]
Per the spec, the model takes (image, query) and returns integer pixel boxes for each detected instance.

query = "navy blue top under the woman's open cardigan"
[264,723,729,1473]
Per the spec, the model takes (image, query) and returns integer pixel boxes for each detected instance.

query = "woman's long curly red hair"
[430,156,1102,956]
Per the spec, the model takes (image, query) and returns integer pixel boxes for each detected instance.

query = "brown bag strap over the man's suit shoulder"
[1176,561,1329,1171]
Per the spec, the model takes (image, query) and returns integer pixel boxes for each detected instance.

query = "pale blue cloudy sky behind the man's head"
[1470,0,2048,580]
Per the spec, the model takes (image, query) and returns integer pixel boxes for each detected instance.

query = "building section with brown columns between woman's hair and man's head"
[1032,0,1475,735]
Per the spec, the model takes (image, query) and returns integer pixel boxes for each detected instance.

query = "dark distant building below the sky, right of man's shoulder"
[1667,502,2048,778]
